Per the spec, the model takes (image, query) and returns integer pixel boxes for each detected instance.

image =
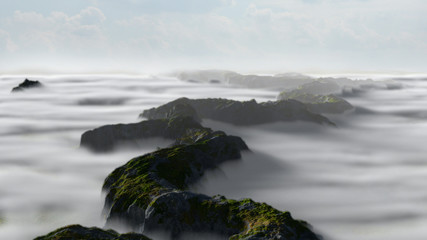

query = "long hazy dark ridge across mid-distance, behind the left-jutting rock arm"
[140,98,333,125]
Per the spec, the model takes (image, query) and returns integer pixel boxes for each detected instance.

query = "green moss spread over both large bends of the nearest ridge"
[104,125,320,239]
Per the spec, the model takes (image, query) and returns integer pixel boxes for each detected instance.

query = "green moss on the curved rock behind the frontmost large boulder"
[103,132,238,211]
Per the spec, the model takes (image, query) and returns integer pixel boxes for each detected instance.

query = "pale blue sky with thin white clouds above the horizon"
[0,0,427,74]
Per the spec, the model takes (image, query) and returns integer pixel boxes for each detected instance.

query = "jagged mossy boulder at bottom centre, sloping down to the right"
[144,191,319,240]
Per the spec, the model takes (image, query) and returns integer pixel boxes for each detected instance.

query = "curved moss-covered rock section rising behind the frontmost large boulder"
[103,132,248,229]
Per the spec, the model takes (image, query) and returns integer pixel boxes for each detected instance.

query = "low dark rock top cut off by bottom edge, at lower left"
[34,225,150,240]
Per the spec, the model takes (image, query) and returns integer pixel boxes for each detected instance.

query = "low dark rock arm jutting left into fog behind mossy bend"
[80,117,207,152]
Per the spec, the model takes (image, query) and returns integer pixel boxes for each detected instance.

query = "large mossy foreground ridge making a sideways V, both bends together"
[103,132,319,240]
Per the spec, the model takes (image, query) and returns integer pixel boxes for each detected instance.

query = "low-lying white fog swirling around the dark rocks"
[0,76,427,240]
